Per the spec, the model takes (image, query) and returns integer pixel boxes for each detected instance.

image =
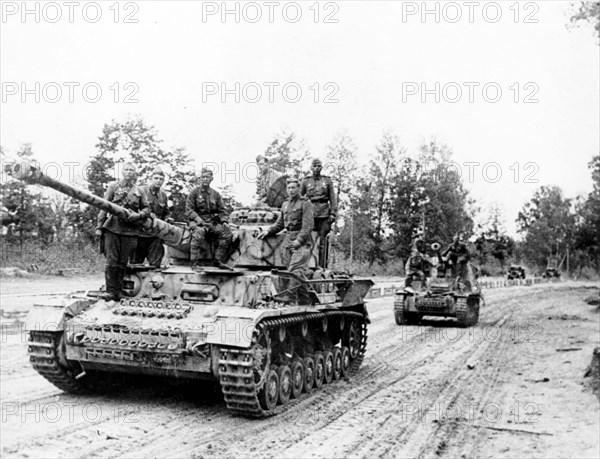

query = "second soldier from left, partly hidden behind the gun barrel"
[133,167,173,268]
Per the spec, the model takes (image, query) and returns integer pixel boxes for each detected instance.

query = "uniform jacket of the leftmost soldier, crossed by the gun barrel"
[97,181,150,236]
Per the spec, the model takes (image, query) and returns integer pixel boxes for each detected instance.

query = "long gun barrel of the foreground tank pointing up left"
[5,161,191,252]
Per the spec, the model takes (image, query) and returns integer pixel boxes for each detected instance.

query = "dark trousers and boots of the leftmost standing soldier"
[104,231,137,300]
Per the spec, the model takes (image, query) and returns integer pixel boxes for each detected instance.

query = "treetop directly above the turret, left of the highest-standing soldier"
[264,128,310,178]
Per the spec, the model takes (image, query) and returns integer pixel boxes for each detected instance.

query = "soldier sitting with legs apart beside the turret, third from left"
[185,169,233,269]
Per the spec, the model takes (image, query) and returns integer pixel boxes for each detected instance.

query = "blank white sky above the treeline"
[0,1,600,234]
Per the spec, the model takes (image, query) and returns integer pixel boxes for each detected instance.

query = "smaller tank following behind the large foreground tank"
[394,243,483,327]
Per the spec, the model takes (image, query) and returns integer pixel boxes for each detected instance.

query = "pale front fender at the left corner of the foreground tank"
[25,297,97,331]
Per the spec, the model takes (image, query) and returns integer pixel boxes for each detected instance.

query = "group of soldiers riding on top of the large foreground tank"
[96,156,337,301]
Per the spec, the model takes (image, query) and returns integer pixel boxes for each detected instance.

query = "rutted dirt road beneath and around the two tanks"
[0,283,600,457]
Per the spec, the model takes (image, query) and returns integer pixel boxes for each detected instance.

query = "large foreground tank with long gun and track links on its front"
[9,163,373,417]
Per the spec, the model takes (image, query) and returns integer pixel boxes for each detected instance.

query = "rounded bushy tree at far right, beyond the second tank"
[517,186,575,267]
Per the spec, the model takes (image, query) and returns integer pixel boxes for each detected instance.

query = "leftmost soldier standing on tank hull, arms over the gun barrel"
[96,163,150,301]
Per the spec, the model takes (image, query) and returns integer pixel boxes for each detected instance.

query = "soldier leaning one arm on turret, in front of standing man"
[258,178,314,275]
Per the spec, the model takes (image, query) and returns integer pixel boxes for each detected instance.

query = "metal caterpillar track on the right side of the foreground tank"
[219,311,367,417]
